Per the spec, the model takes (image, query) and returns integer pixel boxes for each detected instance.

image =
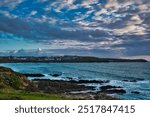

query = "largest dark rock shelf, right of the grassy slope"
[33,79,94,93]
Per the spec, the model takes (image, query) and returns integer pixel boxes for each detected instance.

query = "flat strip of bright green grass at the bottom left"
[0,88,66,100]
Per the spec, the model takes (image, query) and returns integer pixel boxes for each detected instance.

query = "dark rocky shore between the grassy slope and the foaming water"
[28,79,119,100]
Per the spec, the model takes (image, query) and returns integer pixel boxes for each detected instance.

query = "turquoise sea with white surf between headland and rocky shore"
[0,62,150,99]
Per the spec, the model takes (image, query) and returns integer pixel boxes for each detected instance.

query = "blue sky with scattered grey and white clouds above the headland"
[0,0,150,60]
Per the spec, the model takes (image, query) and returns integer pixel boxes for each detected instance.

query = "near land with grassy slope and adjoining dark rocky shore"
[0,67,119,100]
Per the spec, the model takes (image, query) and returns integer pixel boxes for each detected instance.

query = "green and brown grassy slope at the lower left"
[0,67,68,100]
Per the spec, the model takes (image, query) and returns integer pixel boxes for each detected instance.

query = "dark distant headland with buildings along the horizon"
[0,56,148,63]
